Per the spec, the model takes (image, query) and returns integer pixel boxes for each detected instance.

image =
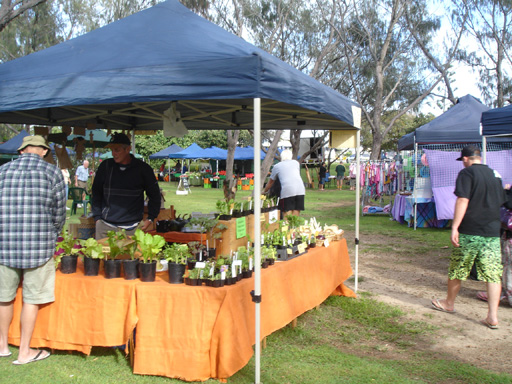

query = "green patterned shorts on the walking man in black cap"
[448,234,503,283]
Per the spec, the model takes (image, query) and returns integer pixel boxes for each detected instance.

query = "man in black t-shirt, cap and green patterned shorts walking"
[432,145,505,329]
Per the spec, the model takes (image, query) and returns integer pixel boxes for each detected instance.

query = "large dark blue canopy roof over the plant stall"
[0,0,360,130]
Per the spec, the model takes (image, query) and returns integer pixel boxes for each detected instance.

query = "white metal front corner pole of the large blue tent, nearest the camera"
[253,98,261,384]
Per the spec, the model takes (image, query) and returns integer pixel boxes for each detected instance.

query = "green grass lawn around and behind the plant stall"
[4,183,512,384]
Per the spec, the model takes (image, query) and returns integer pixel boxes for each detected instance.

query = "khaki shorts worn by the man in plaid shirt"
[0,257,55,304]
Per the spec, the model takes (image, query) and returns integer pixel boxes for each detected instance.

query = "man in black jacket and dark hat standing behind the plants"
[92,133,160,239]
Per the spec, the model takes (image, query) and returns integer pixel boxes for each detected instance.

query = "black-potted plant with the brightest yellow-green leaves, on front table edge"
[133,228,165,281]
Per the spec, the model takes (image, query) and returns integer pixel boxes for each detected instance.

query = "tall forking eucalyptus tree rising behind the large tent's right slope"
[319,0,442,160]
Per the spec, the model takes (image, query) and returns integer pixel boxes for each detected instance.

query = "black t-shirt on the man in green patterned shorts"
[455,164,505,237]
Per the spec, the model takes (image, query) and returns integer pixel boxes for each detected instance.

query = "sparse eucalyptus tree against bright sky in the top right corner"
[452,0,512,107]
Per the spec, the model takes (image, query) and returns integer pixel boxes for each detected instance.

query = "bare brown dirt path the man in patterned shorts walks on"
[345,229,512,374]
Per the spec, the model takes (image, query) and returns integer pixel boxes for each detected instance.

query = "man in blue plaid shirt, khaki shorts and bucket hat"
[0,136,66,365]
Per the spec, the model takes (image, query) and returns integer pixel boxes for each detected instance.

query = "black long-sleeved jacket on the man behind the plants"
[92,155,161,225]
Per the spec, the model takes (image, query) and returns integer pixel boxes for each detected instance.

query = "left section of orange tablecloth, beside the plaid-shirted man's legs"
[9,261,141,355]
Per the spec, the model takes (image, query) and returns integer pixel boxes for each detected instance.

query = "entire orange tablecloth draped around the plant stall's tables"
[9,240,354,380]
